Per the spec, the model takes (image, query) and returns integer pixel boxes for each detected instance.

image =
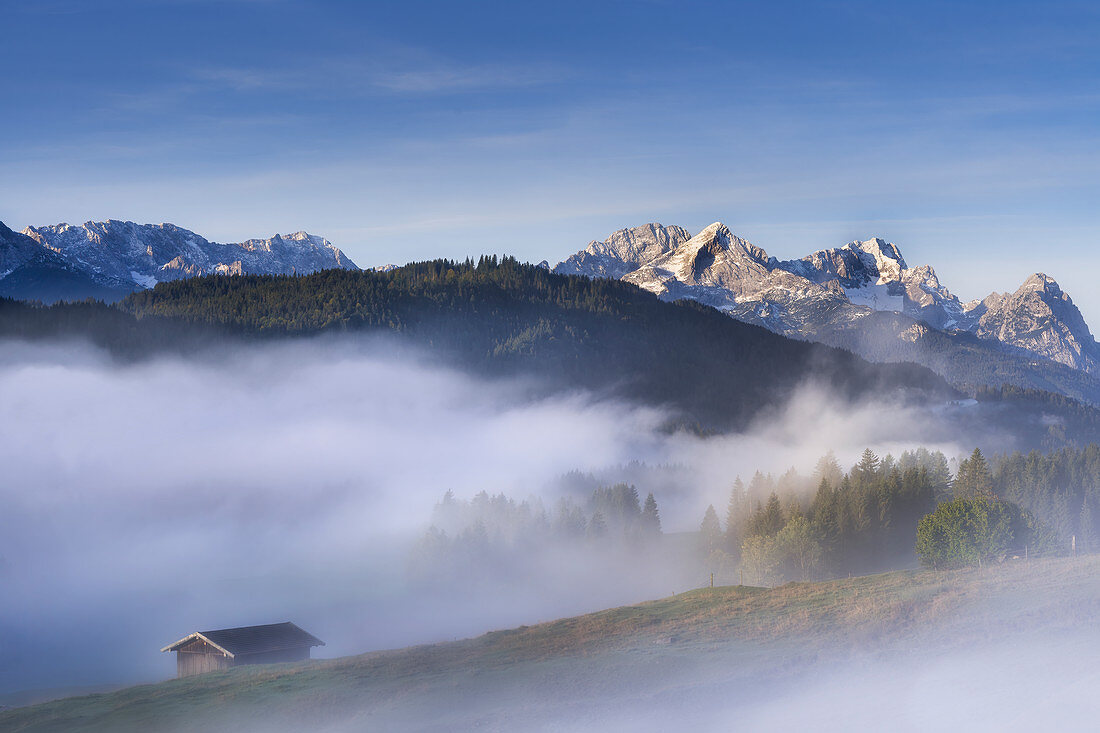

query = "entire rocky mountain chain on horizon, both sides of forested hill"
[0,220,1100,404]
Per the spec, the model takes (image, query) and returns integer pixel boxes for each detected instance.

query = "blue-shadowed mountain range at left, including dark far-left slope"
[0,219,358,303]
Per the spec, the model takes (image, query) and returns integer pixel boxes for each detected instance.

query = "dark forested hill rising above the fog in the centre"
[119,258,950,427]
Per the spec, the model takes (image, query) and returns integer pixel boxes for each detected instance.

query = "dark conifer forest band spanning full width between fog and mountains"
[0,256,1100,440]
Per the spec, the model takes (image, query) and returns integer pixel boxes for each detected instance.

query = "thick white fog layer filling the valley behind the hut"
[0,340,958,691]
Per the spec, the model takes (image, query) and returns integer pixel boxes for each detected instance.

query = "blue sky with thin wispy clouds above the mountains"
[0,0,1100,316]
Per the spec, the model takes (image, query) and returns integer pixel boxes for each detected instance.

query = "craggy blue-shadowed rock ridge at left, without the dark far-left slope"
[23,220,355,287]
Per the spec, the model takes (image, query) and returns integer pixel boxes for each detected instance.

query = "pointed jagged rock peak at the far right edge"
[969,273,1100,372]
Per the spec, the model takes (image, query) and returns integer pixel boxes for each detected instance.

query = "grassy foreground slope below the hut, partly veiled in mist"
[0,557,1100,733]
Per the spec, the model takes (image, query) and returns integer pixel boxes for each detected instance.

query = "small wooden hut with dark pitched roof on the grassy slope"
[161,622,325,677]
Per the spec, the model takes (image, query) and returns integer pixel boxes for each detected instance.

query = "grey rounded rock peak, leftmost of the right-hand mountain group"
[553,223,691,280]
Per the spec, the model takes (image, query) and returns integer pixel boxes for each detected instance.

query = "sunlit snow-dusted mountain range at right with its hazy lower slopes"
[553,222,1100,402]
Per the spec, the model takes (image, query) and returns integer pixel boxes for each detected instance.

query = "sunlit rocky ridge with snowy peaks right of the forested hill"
[554,222,1100,374]
